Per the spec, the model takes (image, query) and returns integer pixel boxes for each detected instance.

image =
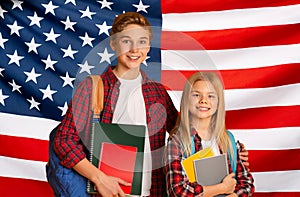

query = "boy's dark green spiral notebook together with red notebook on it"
[87,122,146,195]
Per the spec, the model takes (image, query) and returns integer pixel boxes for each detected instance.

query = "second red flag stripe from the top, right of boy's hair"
[161,24,300,50]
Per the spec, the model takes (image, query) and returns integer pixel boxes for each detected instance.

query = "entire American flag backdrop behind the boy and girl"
[0,0,300,197]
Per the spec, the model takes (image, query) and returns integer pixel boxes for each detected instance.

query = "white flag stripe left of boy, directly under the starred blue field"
[0,113,59,140]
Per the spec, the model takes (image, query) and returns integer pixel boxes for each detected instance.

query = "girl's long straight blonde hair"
[170,72,233,158]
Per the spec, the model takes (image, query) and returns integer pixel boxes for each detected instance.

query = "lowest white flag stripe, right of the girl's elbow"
[252,170,300,192]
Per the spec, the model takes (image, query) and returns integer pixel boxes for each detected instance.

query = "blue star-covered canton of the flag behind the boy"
[0,0,161,120]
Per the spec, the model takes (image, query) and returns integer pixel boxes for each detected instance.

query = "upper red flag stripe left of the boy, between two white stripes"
[0,135,48,161]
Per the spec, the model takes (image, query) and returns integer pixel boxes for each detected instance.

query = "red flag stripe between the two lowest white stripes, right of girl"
[249,149,300,172]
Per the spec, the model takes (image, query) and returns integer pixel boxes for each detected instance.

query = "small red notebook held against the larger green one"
[99,142,137,194]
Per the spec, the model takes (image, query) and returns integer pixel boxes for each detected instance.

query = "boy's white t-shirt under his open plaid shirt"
[112,74,152,196]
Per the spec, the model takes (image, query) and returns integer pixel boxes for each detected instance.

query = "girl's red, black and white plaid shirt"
[166,129,254,197]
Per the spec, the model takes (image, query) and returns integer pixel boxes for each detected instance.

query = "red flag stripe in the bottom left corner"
[0,177,54,197]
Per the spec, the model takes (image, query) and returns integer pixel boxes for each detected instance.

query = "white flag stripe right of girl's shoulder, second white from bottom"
[230,127,300,150]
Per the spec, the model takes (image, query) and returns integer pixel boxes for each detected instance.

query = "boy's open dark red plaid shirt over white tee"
[54,67,178,197]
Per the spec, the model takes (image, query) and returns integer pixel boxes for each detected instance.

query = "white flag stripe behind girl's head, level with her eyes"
[168,82,300,110]
